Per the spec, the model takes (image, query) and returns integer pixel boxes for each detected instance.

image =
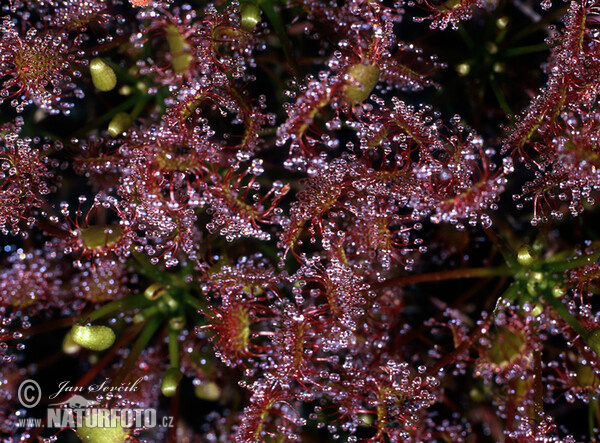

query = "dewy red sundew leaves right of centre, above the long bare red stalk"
[360,98,506,229]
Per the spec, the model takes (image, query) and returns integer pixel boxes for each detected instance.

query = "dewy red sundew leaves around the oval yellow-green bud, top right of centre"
[276,3,441,175]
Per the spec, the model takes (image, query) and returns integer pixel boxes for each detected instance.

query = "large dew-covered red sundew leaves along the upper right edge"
[504,2,599,226]
